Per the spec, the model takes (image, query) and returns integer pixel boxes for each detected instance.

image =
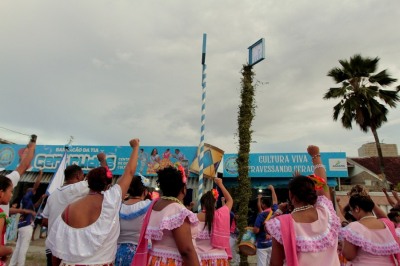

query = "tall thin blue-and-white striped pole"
[197,33,207,211]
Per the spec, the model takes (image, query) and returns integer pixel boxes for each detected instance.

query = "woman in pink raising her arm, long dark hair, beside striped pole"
[196,178,233,266]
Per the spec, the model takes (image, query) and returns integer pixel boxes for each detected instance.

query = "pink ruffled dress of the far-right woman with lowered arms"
[341,219,400,266]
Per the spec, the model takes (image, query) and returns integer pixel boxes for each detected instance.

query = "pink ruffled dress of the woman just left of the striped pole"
[146,203,199,266]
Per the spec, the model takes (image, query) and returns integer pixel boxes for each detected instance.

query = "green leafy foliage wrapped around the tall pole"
[235,65,255,265]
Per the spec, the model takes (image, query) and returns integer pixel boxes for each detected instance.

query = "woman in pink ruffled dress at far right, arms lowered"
[342,194,400,266]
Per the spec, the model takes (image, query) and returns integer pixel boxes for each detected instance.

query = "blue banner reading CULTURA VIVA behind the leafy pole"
[224,152,348,178]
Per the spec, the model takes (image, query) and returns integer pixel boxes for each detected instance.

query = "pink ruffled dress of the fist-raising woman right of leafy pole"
[266,196,340,266]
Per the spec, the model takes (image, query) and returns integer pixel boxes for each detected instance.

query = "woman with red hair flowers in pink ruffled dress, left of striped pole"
[132,166,200,266]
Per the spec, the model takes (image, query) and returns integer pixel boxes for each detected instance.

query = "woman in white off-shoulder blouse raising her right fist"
[46,139,139,266]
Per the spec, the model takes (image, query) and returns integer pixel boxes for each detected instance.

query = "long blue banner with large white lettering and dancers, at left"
[0,144,197,176]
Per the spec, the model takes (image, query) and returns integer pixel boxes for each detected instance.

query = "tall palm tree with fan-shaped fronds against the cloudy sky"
[324,54,400,186]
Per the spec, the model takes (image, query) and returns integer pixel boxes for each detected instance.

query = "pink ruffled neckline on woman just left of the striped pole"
[146,203,199,240]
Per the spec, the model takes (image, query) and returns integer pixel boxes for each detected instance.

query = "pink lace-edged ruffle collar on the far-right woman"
[342,222,400,256]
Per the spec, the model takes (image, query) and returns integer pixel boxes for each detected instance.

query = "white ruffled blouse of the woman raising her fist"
[46,184,121,262]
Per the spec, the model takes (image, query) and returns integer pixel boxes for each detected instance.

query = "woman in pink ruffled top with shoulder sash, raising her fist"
[266,146,340,266]
